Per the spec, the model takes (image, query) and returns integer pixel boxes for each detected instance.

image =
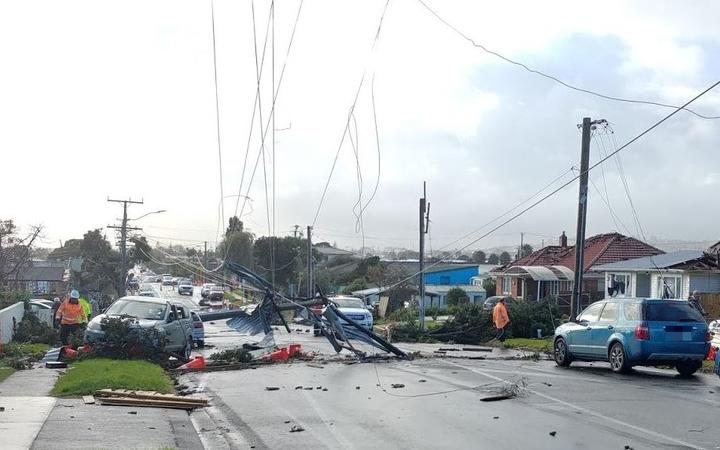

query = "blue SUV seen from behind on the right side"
[554,298,711,376]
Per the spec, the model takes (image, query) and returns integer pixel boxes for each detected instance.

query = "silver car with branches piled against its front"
[85,296,193,358]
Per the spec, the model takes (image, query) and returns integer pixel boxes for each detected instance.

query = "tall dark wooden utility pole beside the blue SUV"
[570,117,605,320]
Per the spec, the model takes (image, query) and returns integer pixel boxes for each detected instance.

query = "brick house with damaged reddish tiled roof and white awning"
[491,232,663,304]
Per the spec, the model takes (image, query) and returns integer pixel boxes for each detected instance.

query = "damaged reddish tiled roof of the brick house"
[501,233,664,271]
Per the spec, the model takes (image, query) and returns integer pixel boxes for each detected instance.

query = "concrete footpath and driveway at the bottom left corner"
[0,367,203,450]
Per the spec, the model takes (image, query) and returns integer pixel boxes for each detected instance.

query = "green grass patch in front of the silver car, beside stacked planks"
[50,358,174,397]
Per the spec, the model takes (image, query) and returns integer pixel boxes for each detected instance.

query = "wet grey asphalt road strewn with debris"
[159,290,720,450]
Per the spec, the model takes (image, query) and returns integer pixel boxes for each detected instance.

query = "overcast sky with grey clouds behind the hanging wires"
[0,0,720,250]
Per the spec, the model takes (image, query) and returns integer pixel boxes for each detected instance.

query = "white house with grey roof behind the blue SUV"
[594,250,720,298]
